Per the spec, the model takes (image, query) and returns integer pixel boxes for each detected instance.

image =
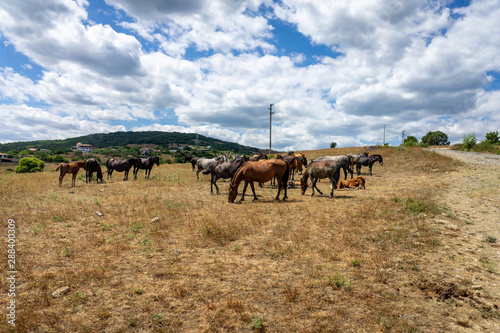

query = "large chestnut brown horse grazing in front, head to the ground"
[227,159,290,203]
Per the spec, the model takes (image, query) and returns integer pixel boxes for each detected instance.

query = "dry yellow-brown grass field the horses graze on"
[0,148,500,332]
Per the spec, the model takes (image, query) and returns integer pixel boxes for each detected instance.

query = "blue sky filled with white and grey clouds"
[0,0,500,150]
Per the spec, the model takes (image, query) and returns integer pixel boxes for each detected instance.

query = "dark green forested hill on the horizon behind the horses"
[0,131,258,154]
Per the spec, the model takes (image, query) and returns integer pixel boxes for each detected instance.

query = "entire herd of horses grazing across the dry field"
[56,152,383,203]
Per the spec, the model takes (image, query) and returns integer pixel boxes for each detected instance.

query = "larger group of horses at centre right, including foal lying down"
[184,152,384,203]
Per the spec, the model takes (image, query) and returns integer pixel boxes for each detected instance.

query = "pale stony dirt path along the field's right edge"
[433,149,500,332]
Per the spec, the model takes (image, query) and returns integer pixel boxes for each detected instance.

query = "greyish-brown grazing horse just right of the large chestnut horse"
[300,160,341,198]
